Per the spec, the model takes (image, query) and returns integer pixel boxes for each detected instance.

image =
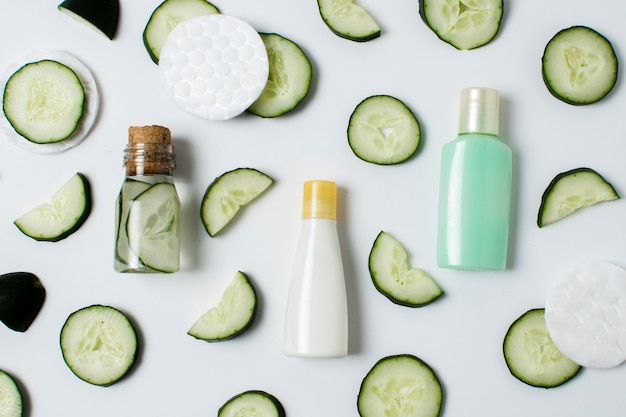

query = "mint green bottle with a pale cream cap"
[437,87,512,271]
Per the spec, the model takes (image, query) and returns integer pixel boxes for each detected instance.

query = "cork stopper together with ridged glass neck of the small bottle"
[124,125,176,176]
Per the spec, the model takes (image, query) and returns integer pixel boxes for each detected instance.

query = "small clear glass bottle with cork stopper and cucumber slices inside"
[114,126,180,273]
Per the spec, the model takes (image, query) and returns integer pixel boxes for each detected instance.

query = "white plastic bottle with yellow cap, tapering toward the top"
[284,180,348,358]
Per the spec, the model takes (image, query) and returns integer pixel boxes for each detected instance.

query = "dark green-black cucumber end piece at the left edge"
[0,272,46,332]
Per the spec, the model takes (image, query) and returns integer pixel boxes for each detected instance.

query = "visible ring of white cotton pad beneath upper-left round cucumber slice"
[0,51,100,154]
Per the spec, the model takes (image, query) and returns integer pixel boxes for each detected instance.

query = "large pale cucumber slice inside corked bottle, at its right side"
[126,182,180,273]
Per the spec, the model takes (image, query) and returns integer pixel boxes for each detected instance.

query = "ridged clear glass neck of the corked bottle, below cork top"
[124,143,176,177]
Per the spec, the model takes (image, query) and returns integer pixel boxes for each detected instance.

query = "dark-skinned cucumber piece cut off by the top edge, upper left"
[57,0,120,40]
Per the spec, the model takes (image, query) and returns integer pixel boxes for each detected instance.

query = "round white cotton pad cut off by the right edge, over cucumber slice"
[545,261,626,368]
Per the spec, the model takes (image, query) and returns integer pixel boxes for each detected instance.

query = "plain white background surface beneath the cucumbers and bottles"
[0,0,626,417]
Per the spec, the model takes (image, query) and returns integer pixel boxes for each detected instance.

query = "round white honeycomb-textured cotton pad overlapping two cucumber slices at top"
[159,14,269,120]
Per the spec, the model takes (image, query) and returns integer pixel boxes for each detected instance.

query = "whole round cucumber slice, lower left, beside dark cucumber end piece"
[60,305,137,386]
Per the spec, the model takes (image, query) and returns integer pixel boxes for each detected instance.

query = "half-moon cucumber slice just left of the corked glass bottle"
[13,173,91,242]
